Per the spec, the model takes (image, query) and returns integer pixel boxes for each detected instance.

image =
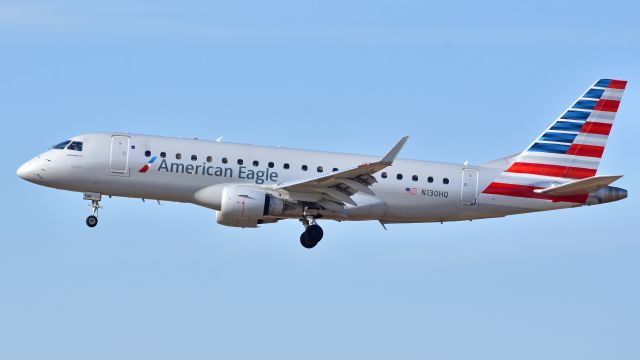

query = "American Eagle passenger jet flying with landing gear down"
[17,79,627,249]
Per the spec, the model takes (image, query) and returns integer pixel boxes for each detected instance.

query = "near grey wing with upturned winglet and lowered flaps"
[273,136,409,213]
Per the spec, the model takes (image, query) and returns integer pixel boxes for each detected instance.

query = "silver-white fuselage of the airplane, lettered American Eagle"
[19,133,592,223]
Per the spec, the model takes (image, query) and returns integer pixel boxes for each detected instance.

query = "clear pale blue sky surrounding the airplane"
[0,0,640,360]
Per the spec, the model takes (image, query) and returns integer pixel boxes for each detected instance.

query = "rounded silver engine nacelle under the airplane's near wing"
[216,185,284,227]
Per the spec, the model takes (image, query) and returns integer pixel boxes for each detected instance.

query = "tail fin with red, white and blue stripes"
[484,79,627,201]
